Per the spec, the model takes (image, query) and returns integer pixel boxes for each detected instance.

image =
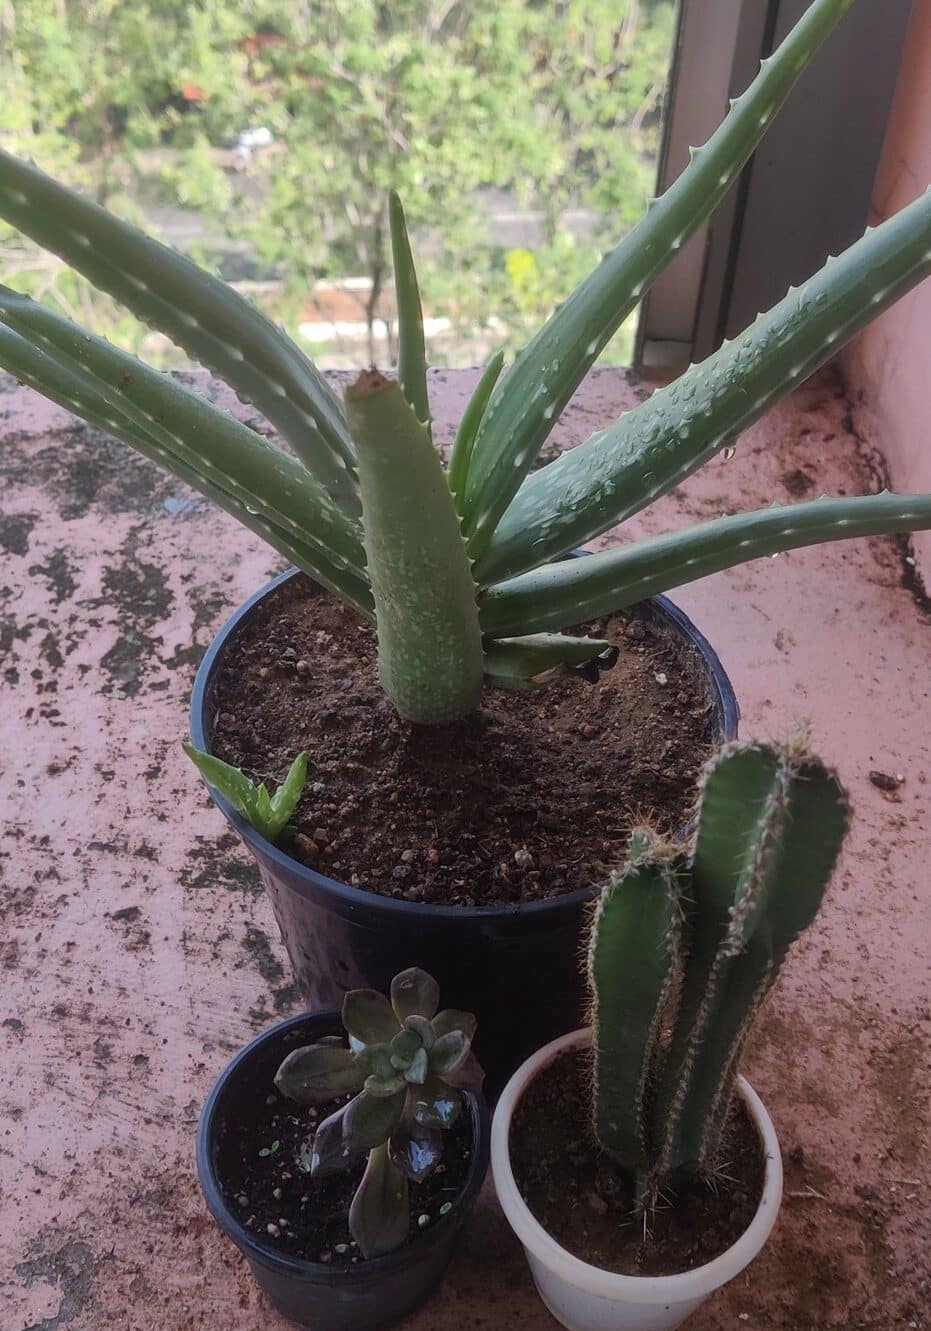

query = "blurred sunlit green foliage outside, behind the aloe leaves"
[0,0,675,359]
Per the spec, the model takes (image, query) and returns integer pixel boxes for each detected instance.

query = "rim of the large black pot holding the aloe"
[190,567,741,921]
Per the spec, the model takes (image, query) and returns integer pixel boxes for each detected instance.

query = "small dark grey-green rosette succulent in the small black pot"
[274,966,483,1258]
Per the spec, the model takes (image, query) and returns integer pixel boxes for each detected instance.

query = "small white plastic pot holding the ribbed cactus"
[491,1030,782,1331]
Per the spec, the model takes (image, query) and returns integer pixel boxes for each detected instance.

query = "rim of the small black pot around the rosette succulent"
[196,1008,489,1280]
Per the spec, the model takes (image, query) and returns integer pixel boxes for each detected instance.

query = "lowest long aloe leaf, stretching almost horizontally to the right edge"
[481,492,931,638]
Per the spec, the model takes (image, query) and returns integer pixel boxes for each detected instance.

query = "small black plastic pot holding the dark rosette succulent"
[197,1009,489,1331]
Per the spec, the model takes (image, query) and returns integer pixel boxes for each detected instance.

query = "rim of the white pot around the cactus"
[491,1028,782,1303]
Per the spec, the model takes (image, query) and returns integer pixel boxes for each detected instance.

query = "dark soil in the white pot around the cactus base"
[510,1053,766,1275]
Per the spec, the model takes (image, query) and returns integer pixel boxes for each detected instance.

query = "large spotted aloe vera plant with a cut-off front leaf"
[0,0,931,724]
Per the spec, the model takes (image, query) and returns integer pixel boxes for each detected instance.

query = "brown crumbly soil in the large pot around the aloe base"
[208,578,715,905]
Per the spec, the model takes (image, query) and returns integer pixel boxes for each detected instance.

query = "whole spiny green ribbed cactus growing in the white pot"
[589,741,847,1207]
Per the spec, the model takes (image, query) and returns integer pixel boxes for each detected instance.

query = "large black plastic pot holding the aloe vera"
[190,570,739,1098]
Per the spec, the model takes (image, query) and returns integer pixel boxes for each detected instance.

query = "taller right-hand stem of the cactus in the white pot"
[657,745,847,1174]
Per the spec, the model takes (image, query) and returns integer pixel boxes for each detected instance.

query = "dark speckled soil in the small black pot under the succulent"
[218,1032,471,1266]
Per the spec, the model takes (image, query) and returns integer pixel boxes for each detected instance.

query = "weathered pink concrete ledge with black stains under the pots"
[0,371,931,1331]
